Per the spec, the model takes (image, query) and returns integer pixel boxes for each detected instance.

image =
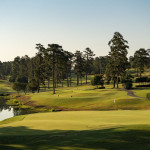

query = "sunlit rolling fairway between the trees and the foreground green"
[28,85,150,110]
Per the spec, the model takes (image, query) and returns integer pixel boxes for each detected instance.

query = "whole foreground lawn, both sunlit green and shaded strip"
[0,110,150,150]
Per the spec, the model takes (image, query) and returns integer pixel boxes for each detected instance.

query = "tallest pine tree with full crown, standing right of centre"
[107,32,129,88]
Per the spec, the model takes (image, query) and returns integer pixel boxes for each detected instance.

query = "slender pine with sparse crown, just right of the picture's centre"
[84,48,95,84]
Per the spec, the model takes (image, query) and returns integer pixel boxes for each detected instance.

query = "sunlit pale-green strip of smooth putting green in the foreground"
[0,111,150,134]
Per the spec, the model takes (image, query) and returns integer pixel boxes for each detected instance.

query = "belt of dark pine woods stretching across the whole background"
[0,32,150,94]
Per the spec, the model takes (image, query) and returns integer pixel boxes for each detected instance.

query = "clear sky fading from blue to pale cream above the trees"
[0,0,150,62]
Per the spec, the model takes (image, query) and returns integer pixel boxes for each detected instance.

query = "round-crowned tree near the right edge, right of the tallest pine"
[134,48,149,78]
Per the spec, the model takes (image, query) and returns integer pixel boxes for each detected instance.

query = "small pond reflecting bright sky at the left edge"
[0,96,30,121]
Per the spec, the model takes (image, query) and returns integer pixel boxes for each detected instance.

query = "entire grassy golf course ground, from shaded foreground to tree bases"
[0,80,150,150]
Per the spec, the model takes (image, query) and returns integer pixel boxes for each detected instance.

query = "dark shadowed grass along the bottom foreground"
[0,125,150,150]
